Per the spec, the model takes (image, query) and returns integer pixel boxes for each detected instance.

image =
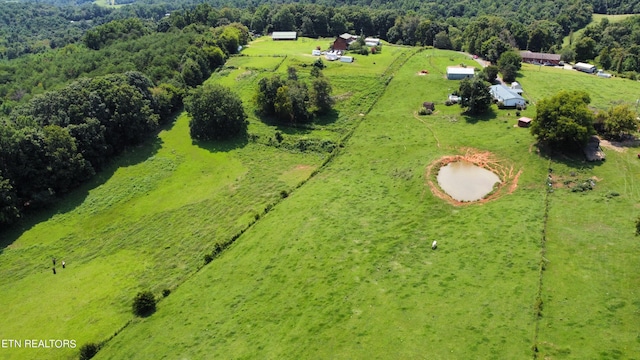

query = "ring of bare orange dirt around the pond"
[425,148,522,206]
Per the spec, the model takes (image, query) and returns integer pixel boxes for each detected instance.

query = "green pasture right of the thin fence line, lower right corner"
[538,152,640,359]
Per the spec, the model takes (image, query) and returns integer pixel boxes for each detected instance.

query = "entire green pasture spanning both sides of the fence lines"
[0,38,640,359]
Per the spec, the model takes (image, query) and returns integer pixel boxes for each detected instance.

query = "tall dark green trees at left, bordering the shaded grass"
[0,72,171,223]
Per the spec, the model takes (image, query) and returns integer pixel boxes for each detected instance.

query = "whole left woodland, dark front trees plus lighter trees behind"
[0,19,248,223]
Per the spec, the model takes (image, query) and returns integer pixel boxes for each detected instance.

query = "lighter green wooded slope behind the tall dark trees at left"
[0,19,248,114]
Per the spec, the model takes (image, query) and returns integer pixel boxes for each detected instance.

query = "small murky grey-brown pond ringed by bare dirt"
[438,161,500,201]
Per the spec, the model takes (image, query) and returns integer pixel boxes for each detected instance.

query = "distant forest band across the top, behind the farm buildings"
[0,0,635,68]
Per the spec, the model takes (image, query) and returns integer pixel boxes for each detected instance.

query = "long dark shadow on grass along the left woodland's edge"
[0,118,175,255]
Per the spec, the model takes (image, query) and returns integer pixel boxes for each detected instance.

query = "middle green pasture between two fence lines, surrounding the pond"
[97,51,547,359]
